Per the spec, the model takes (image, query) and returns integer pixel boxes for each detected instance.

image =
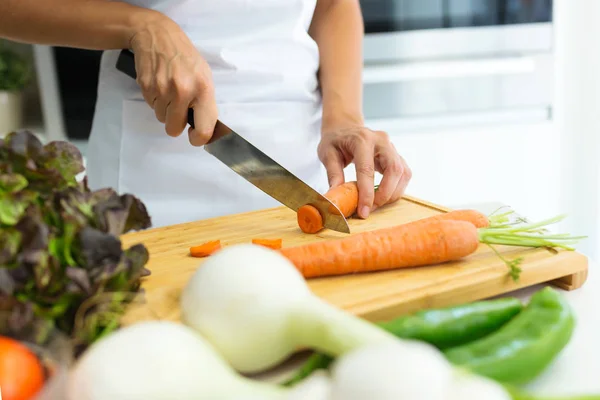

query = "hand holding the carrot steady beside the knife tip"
[318,125,412,218]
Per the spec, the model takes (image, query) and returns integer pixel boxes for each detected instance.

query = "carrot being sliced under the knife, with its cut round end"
[296,182,358,233]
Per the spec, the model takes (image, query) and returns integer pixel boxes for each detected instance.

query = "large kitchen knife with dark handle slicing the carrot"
[117,49,350,233]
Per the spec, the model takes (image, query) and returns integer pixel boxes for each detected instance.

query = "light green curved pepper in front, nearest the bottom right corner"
[445,287,575,384]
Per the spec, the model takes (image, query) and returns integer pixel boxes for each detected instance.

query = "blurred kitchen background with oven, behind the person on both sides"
[0,0,600,256]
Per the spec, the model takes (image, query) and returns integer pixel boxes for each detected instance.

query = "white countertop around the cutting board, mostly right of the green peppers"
[258,203,600,398]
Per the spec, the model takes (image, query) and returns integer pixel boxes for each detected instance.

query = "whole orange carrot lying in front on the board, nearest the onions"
[280,218,479,278]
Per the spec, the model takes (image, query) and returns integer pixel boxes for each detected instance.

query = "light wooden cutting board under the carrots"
[122,197,588,325]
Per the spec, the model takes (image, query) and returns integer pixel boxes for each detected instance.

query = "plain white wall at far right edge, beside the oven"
[554,0,600,259]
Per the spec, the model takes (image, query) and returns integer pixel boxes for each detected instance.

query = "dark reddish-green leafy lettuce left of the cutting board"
[0,131,151,351]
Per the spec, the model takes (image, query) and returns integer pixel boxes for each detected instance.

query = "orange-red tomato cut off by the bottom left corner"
[0,336,45,400]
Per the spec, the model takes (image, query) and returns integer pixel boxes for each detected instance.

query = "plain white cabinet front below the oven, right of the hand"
[347,122,562,219]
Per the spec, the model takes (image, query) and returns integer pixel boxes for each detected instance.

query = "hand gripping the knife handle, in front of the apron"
[130,17,218,146]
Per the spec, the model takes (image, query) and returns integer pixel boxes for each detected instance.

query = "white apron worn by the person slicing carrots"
[87,0,327,227]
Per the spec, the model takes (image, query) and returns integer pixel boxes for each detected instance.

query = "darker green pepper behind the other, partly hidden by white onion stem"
[284,298,523,386]
